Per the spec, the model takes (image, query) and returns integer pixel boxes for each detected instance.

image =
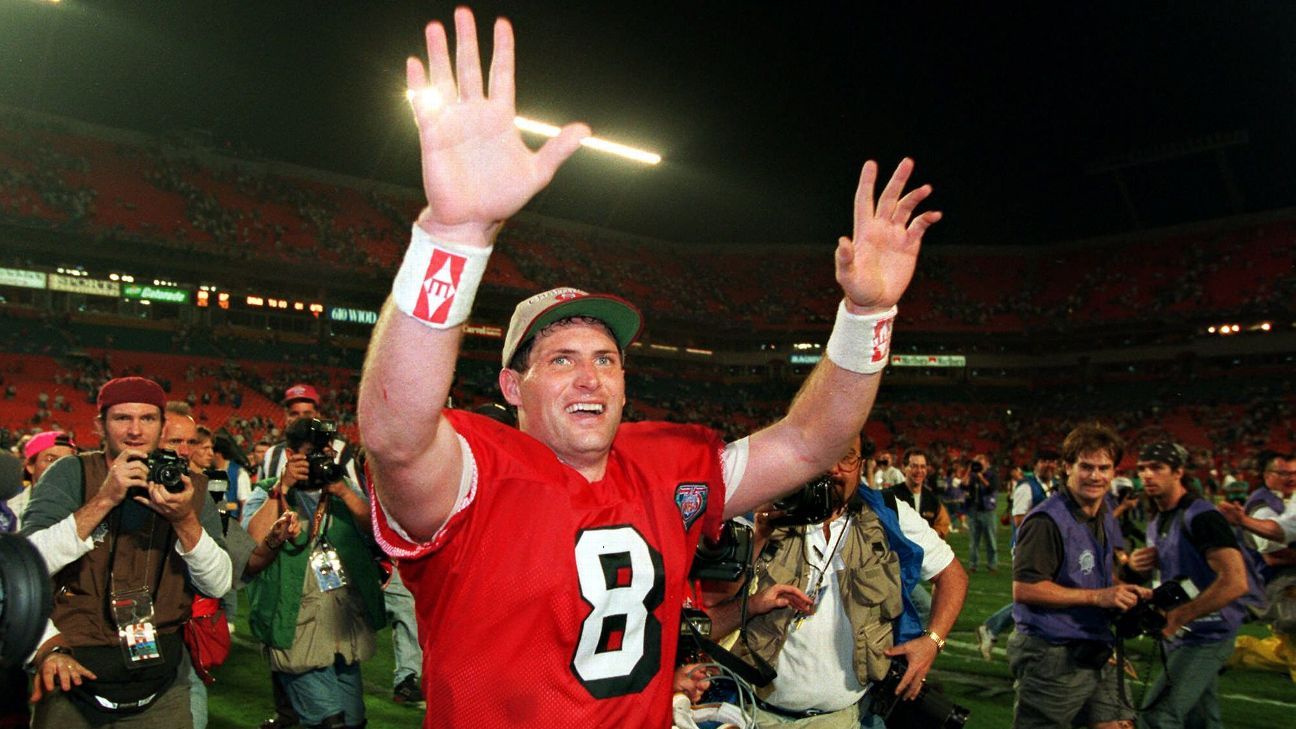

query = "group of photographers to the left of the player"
[0,376,422,729]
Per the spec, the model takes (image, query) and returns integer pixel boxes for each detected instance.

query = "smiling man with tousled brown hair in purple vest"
[1008,424,1151,729]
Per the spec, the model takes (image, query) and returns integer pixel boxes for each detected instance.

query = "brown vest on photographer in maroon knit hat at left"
[52,451,207,646]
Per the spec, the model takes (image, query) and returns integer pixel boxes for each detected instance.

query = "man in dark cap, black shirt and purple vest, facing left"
[1129,442,1262,728]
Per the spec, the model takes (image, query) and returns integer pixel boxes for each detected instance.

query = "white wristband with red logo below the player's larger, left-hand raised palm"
[391,224,491,329]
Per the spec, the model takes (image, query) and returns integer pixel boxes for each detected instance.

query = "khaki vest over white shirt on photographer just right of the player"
[734,507,905,698]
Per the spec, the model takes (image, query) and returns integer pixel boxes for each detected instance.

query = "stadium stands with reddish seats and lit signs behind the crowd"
[0,109,1296,726]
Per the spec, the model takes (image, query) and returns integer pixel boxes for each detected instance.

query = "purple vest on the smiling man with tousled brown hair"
[1012,492,1121,645]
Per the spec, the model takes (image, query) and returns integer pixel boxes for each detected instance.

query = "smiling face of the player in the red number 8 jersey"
[499,319,626,480]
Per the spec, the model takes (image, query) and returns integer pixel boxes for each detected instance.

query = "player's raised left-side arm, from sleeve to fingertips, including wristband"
[359,8,588,538]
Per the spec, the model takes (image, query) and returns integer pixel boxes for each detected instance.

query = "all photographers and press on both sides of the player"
[0,376,1296,728]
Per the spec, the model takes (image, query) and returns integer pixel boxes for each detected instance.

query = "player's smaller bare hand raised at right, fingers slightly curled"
[836,157,941,314]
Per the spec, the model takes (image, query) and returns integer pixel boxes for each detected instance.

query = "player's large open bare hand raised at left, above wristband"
[406,8,590,245]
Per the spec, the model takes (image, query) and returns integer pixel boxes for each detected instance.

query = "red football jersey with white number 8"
[373,411,724,729]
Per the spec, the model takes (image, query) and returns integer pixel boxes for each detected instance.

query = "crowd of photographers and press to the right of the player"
[675,424,1296,729]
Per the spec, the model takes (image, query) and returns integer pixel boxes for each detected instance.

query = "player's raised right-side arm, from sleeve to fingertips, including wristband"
[724,158,941,516]
